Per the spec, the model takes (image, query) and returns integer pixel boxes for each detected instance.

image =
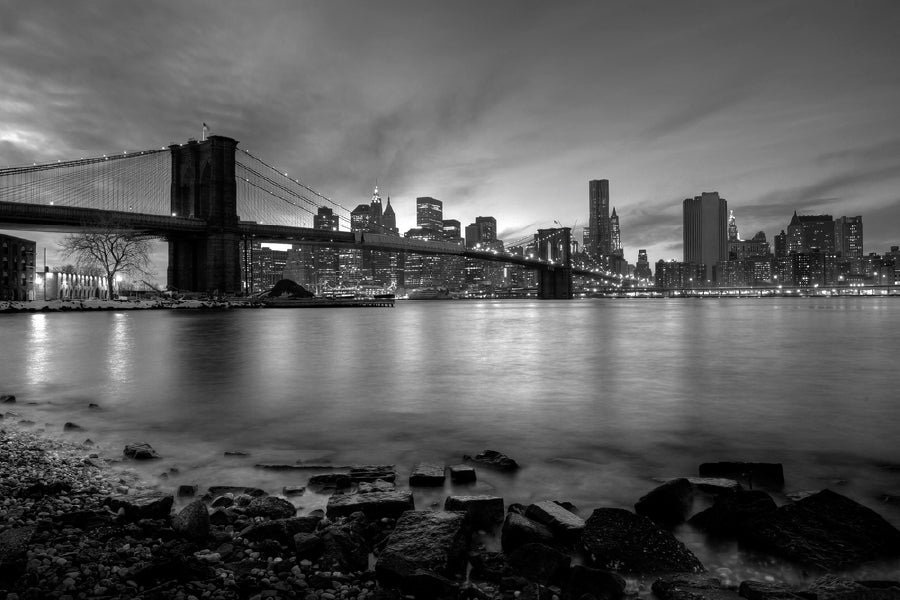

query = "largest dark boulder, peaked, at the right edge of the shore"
[738,490,900,572]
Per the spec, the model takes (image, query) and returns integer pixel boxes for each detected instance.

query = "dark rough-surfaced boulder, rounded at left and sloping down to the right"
[582,508,704,573]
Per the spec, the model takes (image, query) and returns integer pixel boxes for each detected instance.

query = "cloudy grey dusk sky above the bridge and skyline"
[0,0,900,273]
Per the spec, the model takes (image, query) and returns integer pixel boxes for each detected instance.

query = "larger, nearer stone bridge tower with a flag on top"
[167,135,241,293]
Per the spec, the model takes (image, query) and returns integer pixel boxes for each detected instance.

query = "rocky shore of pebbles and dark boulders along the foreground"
[0,404,900,600]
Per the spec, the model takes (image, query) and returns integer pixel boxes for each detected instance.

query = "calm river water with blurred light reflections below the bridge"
[0,298,900,575]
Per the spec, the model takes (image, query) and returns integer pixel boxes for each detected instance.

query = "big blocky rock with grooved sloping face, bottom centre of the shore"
[375,511,468,590]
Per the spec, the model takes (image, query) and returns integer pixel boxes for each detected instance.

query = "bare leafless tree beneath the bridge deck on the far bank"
[59,221,152,298]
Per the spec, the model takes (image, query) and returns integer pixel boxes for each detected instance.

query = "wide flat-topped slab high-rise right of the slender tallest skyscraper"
[683,192,728,280]
